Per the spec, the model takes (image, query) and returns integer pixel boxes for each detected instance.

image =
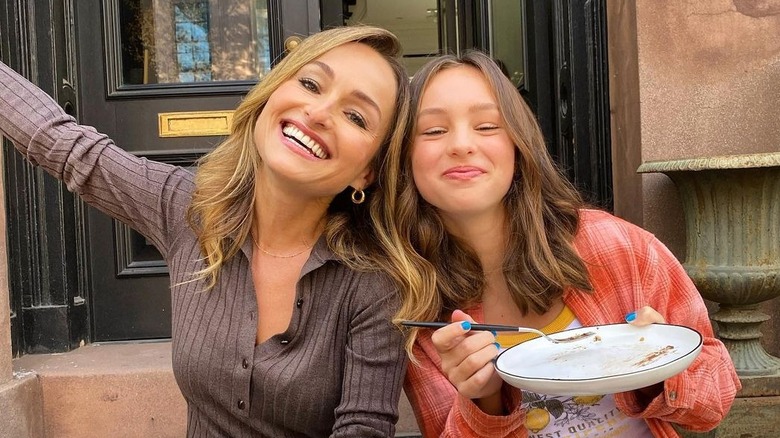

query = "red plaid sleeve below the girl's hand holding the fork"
[404,333,527,438]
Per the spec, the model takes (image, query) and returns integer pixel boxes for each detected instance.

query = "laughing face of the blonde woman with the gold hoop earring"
[254,43,397,198]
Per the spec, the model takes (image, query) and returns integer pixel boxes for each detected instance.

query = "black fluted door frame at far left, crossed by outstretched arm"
[0,0,89,356]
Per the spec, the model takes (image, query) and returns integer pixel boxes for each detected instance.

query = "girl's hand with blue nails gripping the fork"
[431,310,503,415]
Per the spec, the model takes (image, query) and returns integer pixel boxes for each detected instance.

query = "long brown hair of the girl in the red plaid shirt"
[386,51,591,350]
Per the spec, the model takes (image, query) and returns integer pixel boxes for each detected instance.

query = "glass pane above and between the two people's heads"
[345,0,444,75]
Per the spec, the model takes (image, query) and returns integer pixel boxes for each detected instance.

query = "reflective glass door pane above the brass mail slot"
[117,0,271,85]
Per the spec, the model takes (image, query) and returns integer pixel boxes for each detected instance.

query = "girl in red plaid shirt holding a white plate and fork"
[388,52,740,438]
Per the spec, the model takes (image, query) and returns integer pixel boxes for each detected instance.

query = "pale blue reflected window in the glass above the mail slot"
[173,2,211,82]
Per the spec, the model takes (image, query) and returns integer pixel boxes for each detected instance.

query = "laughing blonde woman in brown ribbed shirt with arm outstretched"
[0,27,408,437]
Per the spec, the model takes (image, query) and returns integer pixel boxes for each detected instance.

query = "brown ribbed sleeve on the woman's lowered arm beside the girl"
[332,274,407,438]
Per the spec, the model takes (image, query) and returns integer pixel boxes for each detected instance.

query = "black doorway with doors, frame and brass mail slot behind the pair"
[0,0,611,354]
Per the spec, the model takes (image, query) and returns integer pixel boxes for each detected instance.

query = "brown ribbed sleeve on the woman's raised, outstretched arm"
[0,63,192,254]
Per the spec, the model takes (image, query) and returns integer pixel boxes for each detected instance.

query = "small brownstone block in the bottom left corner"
[0,373,43,438]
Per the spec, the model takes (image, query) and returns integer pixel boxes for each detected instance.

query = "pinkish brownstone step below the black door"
[9,342,419,438]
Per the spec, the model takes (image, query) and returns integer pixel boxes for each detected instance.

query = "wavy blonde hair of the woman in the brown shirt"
[187,26,409,289]
